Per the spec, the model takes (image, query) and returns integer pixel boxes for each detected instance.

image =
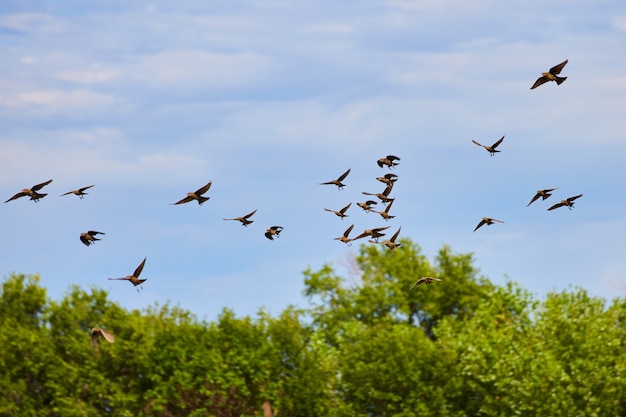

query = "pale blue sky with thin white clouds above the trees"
[0,0,626,320]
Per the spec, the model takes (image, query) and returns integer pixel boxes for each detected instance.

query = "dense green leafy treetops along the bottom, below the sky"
[0,240,626,417]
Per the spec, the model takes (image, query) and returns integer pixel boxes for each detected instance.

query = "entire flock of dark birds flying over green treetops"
[5,60,582,347]
